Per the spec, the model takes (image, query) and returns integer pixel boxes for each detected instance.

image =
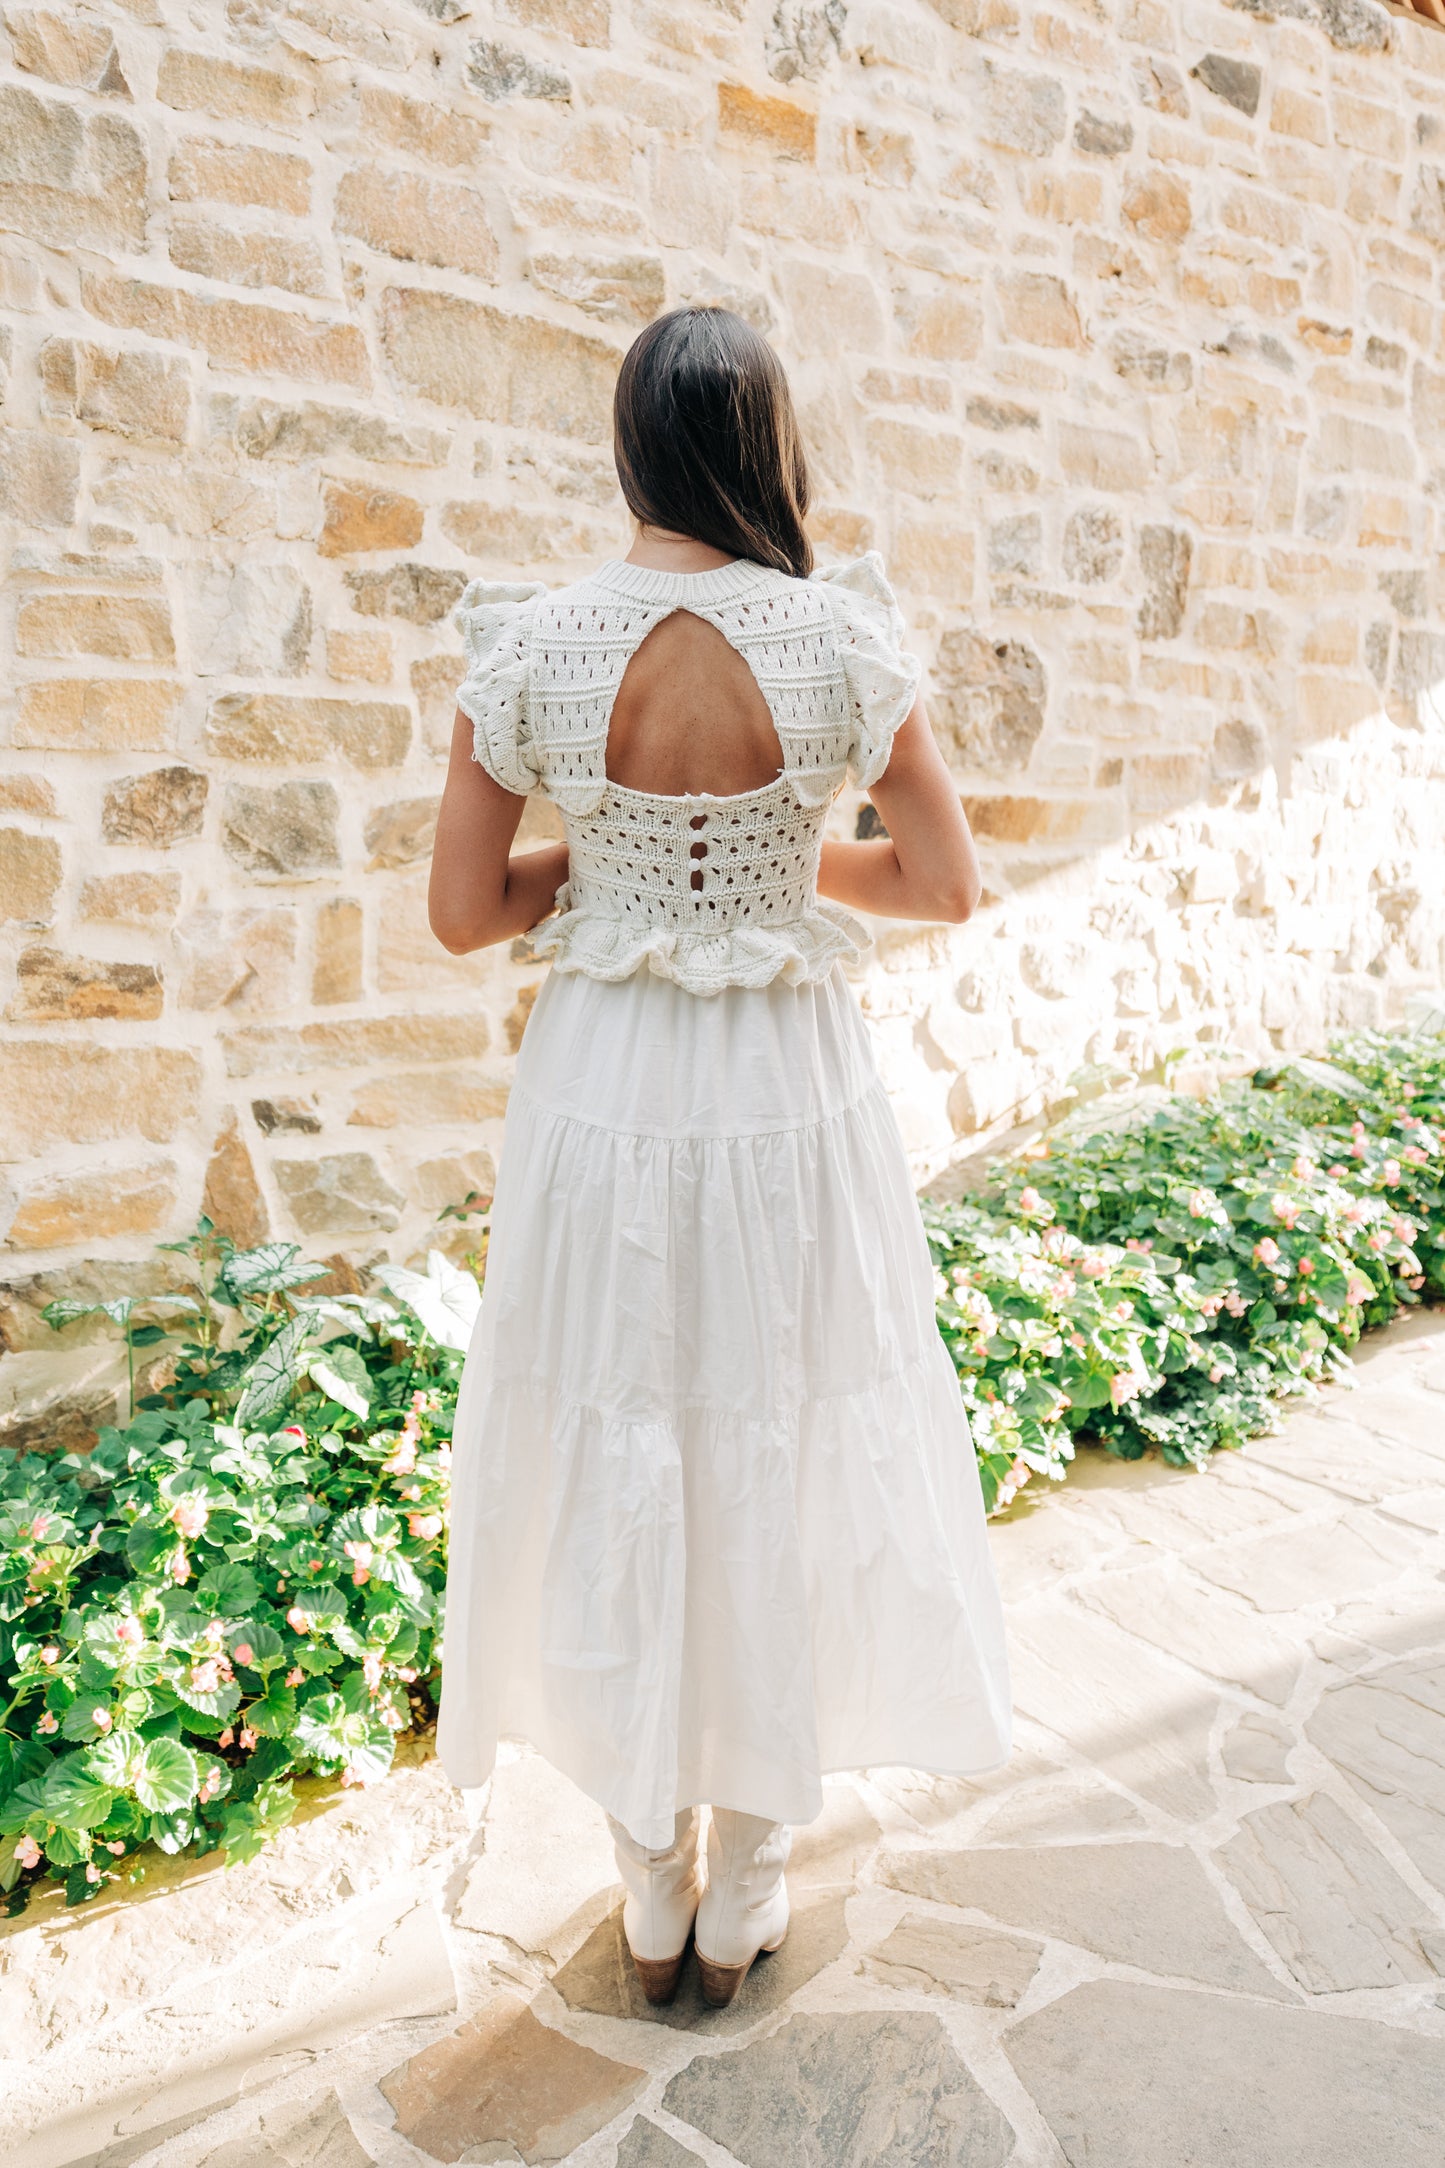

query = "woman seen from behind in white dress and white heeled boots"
[431,308,1010,2003]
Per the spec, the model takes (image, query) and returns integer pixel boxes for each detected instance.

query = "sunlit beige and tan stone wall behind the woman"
[0,0,1445,1344]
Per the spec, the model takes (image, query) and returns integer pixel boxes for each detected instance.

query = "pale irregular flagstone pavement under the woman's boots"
[0,1312,1445,2168]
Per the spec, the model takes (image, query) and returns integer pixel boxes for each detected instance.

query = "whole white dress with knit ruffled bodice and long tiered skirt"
[438,551,1010,1847]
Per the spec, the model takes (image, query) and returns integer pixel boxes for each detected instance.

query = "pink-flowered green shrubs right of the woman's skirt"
[927,1034,1445,1509]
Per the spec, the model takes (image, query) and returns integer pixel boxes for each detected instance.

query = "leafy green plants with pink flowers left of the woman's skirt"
[0,1223,465,1910]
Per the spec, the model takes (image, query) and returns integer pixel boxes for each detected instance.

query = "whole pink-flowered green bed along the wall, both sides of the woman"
[0,1036,1445,1910]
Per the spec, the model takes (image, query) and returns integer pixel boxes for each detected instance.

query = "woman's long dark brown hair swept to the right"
[613,306,812,579]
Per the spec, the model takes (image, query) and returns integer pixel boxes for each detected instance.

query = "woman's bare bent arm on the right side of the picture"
[819,700,984,926]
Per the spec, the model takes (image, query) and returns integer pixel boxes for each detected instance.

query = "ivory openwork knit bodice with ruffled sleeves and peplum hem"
[457,551,919,993]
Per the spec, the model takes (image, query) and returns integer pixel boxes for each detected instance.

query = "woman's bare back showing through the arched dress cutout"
[607,609,782,798]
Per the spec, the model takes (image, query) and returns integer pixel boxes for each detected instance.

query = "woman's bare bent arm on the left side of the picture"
[427,709,568,956]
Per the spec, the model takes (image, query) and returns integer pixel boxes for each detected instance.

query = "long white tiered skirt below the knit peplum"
[438,969,1010,1845]
